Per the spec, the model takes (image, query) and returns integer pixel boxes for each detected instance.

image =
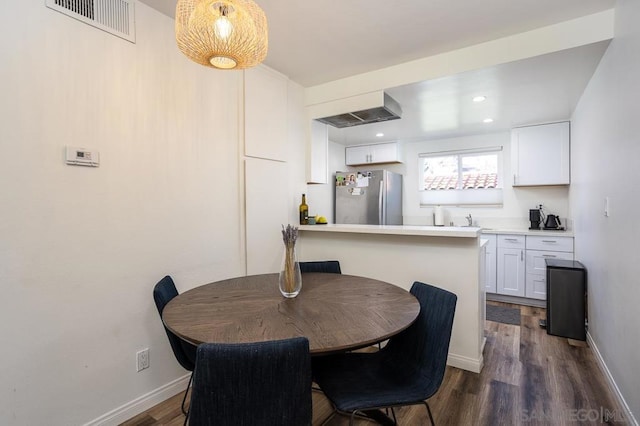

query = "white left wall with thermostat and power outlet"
[0,1,304,425]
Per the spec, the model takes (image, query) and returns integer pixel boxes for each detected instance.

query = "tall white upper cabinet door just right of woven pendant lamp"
[244,66,288,161]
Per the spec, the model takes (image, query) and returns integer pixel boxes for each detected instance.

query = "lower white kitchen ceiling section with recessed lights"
[329,42,609,145]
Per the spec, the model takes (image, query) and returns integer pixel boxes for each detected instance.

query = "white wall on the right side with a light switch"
[570,0,640,418]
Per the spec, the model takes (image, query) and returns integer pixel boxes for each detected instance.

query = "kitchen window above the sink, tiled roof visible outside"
[418,147,502,206]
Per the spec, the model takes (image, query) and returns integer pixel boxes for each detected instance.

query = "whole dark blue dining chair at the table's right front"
[313,282,457,425]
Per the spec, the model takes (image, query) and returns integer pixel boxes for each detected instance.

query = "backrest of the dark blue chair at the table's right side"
[384,281,458,394]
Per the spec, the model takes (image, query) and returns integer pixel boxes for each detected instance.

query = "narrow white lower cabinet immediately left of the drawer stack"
[496,235,525,297]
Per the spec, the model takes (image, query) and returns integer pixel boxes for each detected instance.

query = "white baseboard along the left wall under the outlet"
[84,373,191,426]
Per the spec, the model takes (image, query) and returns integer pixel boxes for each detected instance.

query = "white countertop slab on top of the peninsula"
[298,224,482,238]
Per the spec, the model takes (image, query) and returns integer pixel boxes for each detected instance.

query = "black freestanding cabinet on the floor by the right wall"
[546,259,587,340]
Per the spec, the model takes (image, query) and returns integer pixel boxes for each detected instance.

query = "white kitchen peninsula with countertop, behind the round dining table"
[298,225,485,373]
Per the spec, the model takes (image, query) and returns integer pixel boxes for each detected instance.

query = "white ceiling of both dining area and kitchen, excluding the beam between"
[140,0,615,145]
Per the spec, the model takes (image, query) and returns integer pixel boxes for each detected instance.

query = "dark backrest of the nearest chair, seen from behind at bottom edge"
[189,337,312,426]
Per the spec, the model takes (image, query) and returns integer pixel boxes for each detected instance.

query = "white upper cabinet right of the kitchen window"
[511,121,571,186]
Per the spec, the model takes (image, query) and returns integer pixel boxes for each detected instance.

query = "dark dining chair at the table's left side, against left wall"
[153,275,196,416]
